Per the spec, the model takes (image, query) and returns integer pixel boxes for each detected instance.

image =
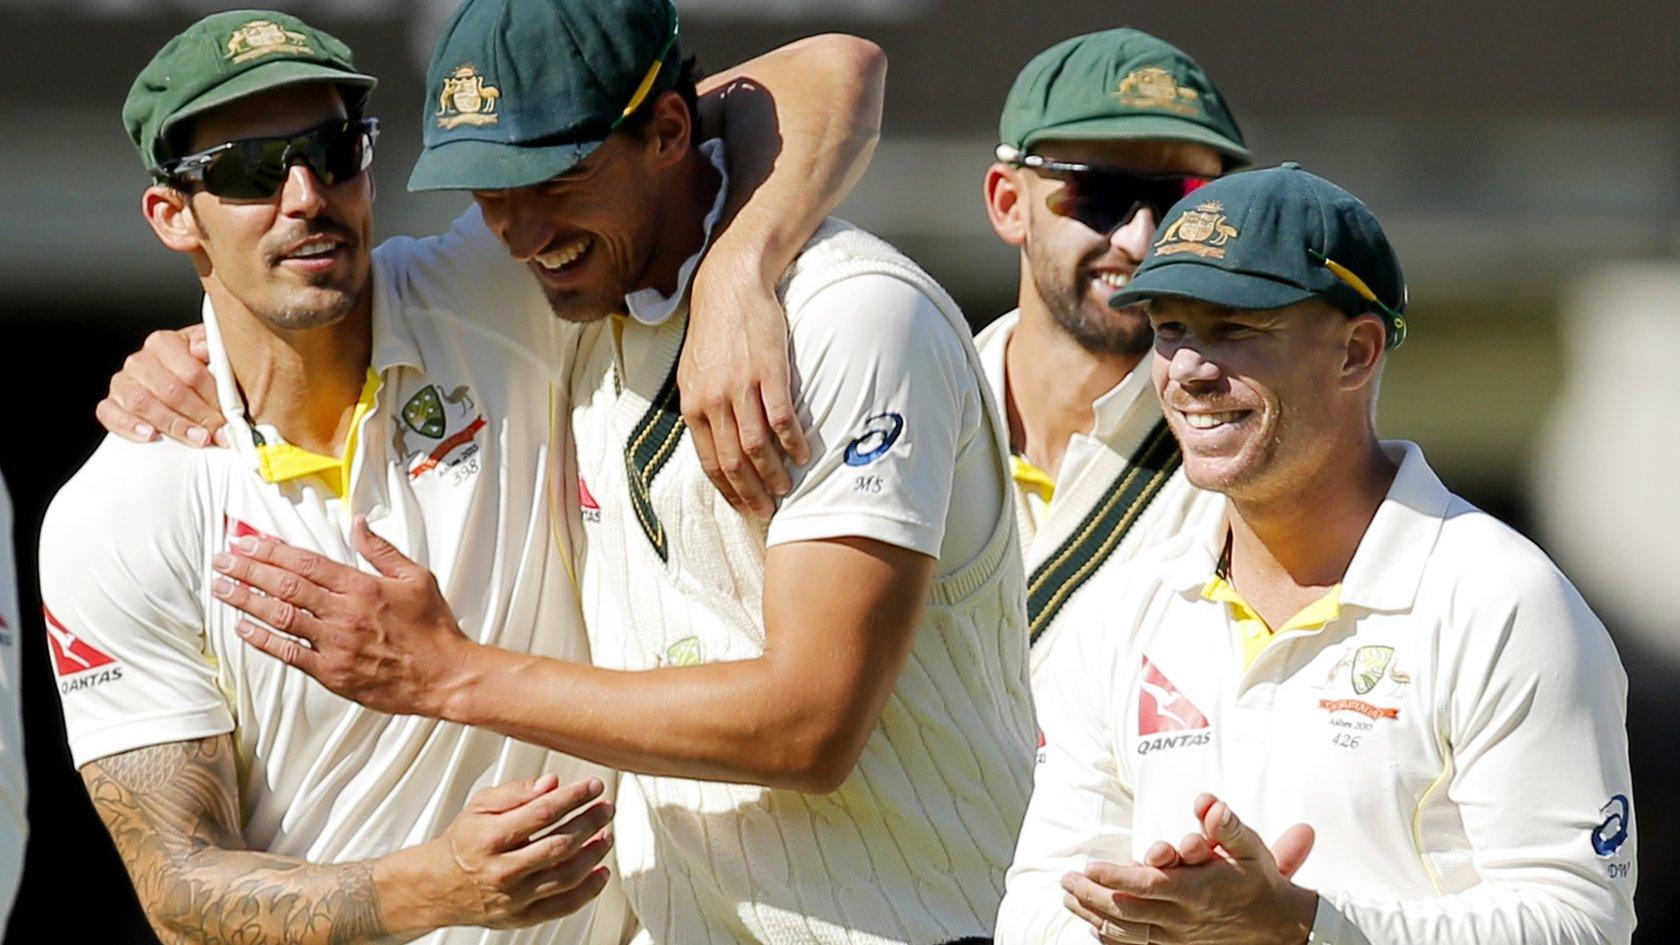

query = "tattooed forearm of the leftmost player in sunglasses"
[82,735,396,945]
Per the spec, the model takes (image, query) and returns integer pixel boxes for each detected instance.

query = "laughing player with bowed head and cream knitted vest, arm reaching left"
[196,0,1033,945]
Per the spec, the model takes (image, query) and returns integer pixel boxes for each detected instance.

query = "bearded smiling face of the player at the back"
[1016,141,1223,355]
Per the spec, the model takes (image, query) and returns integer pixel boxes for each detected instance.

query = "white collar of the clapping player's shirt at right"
[1161,441,1453,610]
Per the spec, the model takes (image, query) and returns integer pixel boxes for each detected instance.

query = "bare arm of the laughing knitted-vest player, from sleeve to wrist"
[444,538,934,794]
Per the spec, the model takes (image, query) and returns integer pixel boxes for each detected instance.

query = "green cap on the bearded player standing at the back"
[998,29,1252,170]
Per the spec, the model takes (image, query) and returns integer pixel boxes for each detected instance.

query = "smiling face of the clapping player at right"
[1144,298,1383,501]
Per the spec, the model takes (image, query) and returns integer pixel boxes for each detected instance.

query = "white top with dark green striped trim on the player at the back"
[974,309,1223,693]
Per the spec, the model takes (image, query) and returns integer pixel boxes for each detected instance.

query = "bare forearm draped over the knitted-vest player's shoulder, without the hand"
[701,34,887,284]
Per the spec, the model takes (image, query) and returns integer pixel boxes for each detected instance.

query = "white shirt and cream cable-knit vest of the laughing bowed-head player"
[573,139,1033,945]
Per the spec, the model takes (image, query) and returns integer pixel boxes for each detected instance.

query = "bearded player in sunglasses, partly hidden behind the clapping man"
[974,29,1248,691]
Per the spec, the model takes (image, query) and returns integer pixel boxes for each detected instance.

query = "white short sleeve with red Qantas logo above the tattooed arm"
[40,437,234,767]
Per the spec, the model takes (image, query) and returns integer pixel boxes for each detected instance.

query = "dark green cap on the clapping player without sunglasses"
[1109,161,1406,348]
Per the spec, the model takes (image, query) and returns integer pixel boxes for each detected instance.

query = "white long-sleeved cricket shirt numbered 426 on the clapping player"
[998,442,1638,945]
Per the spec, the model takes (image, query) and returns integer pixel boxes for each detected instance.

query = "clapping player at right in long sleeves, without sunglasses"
[998,165,1638,945]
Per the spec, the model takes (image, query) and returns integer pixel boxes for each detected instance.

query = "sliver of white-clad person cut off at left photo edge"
[0,476,29,928]
